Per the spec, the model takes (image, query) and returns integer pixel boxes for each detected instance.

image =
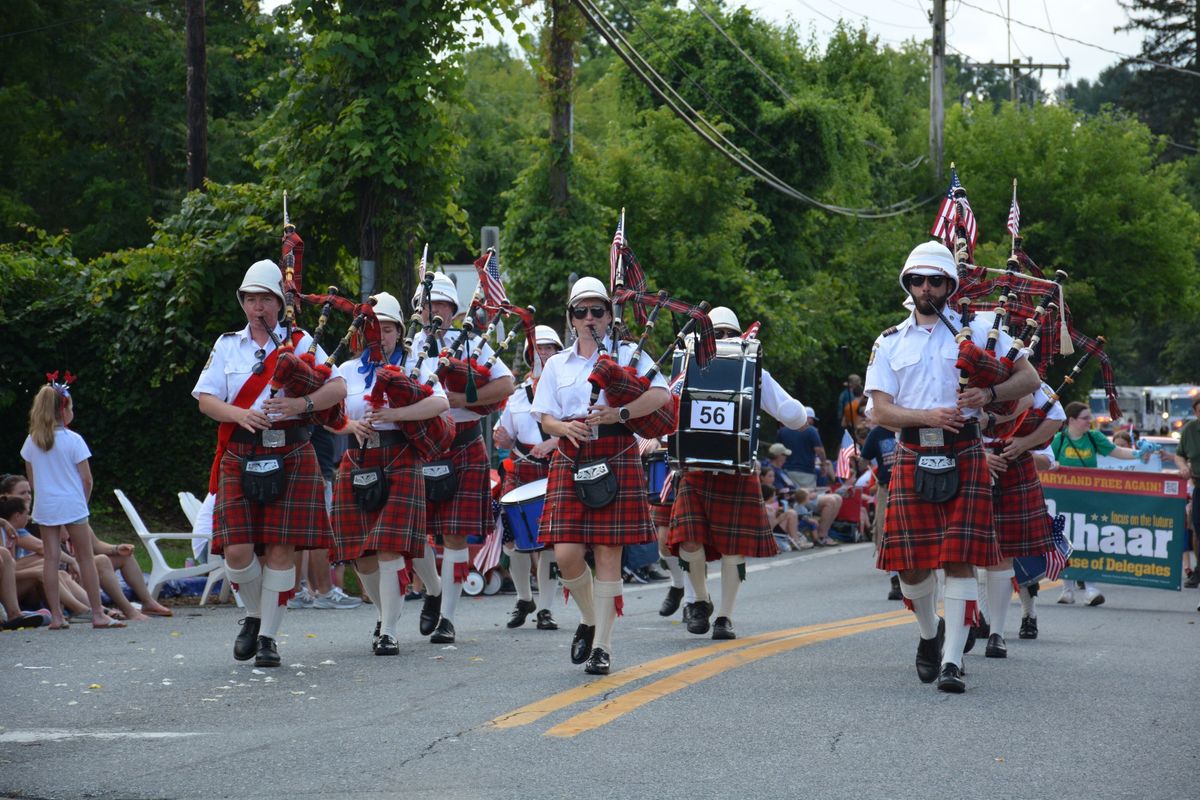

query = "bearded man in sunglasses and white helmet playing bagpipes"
[865,242,1039,692]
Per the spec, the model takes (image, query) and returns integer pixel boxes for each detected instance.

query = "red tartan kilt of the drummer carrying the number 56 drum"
[667,471,779,561]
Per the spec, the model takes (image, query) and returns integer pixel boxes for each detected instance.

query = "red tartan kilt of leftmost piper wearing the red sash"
[212,441,332,553]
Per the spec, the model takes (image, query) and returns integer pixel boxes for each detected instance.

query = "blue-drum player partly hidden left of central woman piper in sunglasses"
[492,325,563,631]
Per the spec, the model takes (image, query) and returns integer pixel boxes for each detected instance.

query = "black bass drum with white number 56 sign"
[670,339,762,475]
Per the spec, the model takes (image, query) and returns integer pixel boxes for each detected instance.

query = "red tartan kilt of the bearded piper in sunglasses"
[876,440,1001,571]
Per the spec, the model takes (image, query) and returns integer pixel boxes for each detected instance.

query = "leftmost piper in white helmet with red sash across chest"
[192,257,346,667]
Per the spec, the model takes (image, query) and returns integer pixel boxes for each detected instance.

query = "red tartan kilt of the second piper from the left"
[330,445,425,561]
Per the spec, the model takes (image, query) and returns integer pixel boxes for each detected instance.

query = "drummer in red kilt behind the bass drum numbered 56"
[667,306,809,639]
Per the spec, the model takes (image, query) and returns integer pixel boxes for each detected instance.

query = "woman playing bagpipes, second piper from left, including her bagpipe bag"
[332,291,451,656]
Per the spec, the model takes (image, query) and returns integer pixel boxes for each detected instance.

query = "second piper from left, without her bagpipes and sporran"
[332,291,450,656]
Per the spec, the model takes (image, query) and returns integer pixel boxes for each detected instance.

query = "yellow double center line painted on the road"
[491,609,914,736]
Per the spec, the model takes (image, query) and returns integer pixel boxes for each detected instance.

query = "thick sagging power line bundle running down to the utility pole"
[572,0,941,219]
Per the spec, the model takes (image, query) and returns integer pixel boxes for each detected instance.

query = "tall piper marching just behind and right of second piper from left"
[413,273,514,644]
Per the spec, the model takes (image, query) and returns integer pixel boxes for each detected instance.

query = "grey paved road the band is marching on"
[0,546,1200,800]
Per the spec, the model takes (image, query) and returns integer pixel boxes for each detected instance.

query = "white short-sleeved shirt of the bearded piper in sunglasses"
[863,308,1025,417]
